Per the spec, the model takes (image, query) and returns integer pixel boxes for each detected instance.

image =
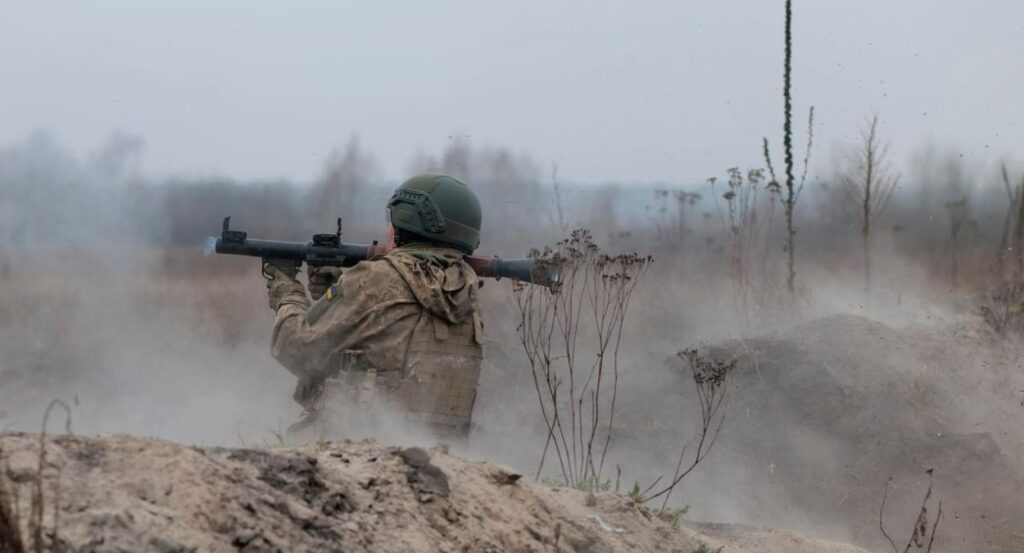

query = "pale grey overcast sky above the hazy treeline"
[0,0,1024,181]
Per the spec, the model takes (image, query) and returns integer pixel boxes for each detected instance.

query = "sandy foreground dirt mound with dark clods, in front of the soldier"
[0,433,862,553]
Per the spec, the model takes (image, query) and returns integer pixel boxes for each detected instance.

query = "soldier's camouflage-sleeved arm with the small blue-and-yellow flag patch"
[270,261,415,378]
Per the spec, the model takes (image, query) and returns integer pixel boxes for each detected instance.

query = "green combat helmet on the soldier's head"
[387,174,481,253]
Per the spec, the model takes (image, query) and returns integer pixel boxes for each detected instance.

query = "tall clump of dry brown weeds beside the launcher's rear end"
[513,229,651,487]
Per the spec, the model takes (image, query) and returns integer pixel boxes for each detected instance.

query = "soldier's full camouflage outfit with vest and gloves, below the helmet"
[271,243,482,436]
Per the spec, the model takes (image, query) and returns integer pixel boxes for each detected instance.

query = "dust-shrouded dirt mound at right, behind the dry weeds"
[706,315,1024,551]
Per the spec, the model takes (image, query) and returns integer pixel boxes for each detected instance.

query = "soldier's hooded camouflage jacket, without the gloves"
[271,244,482,430]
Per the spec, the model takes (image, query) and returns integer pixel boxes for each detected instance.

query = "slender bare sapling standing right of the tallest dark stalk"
[840,114,900,292]
